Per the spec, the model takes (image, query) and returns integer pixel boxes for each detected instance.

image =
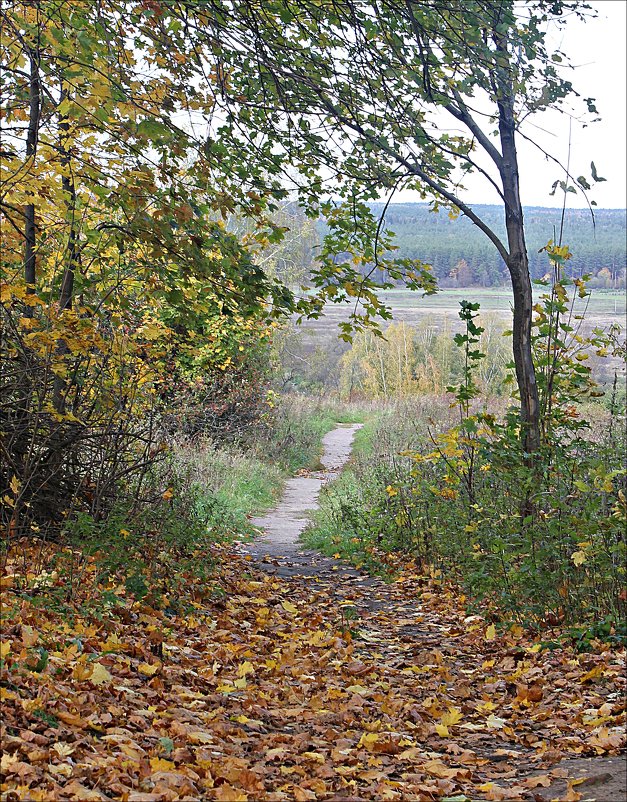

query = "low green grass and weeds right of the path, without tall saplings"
[303,397,626,635]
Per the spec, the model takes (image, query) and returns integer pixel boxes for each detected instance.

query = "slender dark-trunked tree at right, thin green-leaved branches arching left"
[197,0,608,452]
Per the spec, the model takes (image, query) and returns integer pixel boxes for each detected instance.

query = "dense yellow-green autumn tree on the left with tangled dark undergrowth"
[0,0,300,534]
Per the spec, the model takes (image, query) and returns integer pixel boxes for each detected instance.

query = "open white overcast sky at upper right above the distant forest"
[394,0,627,209]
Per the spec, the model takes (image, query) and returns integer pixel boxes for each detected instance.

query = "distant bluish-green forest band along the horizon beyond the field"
[319,203,627,288]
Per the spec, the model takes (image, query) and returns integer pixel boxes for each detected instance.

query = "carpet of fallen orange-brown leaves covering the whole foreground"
[0,422,625,802]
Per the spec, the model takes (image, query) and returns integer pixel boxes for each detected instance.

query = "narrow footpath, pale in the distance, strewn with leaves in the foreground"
[243,424,627,802]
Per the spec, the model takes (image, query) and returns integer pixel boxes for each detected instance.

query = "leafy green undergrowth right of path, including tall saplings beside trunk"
[307,279,627,631]
